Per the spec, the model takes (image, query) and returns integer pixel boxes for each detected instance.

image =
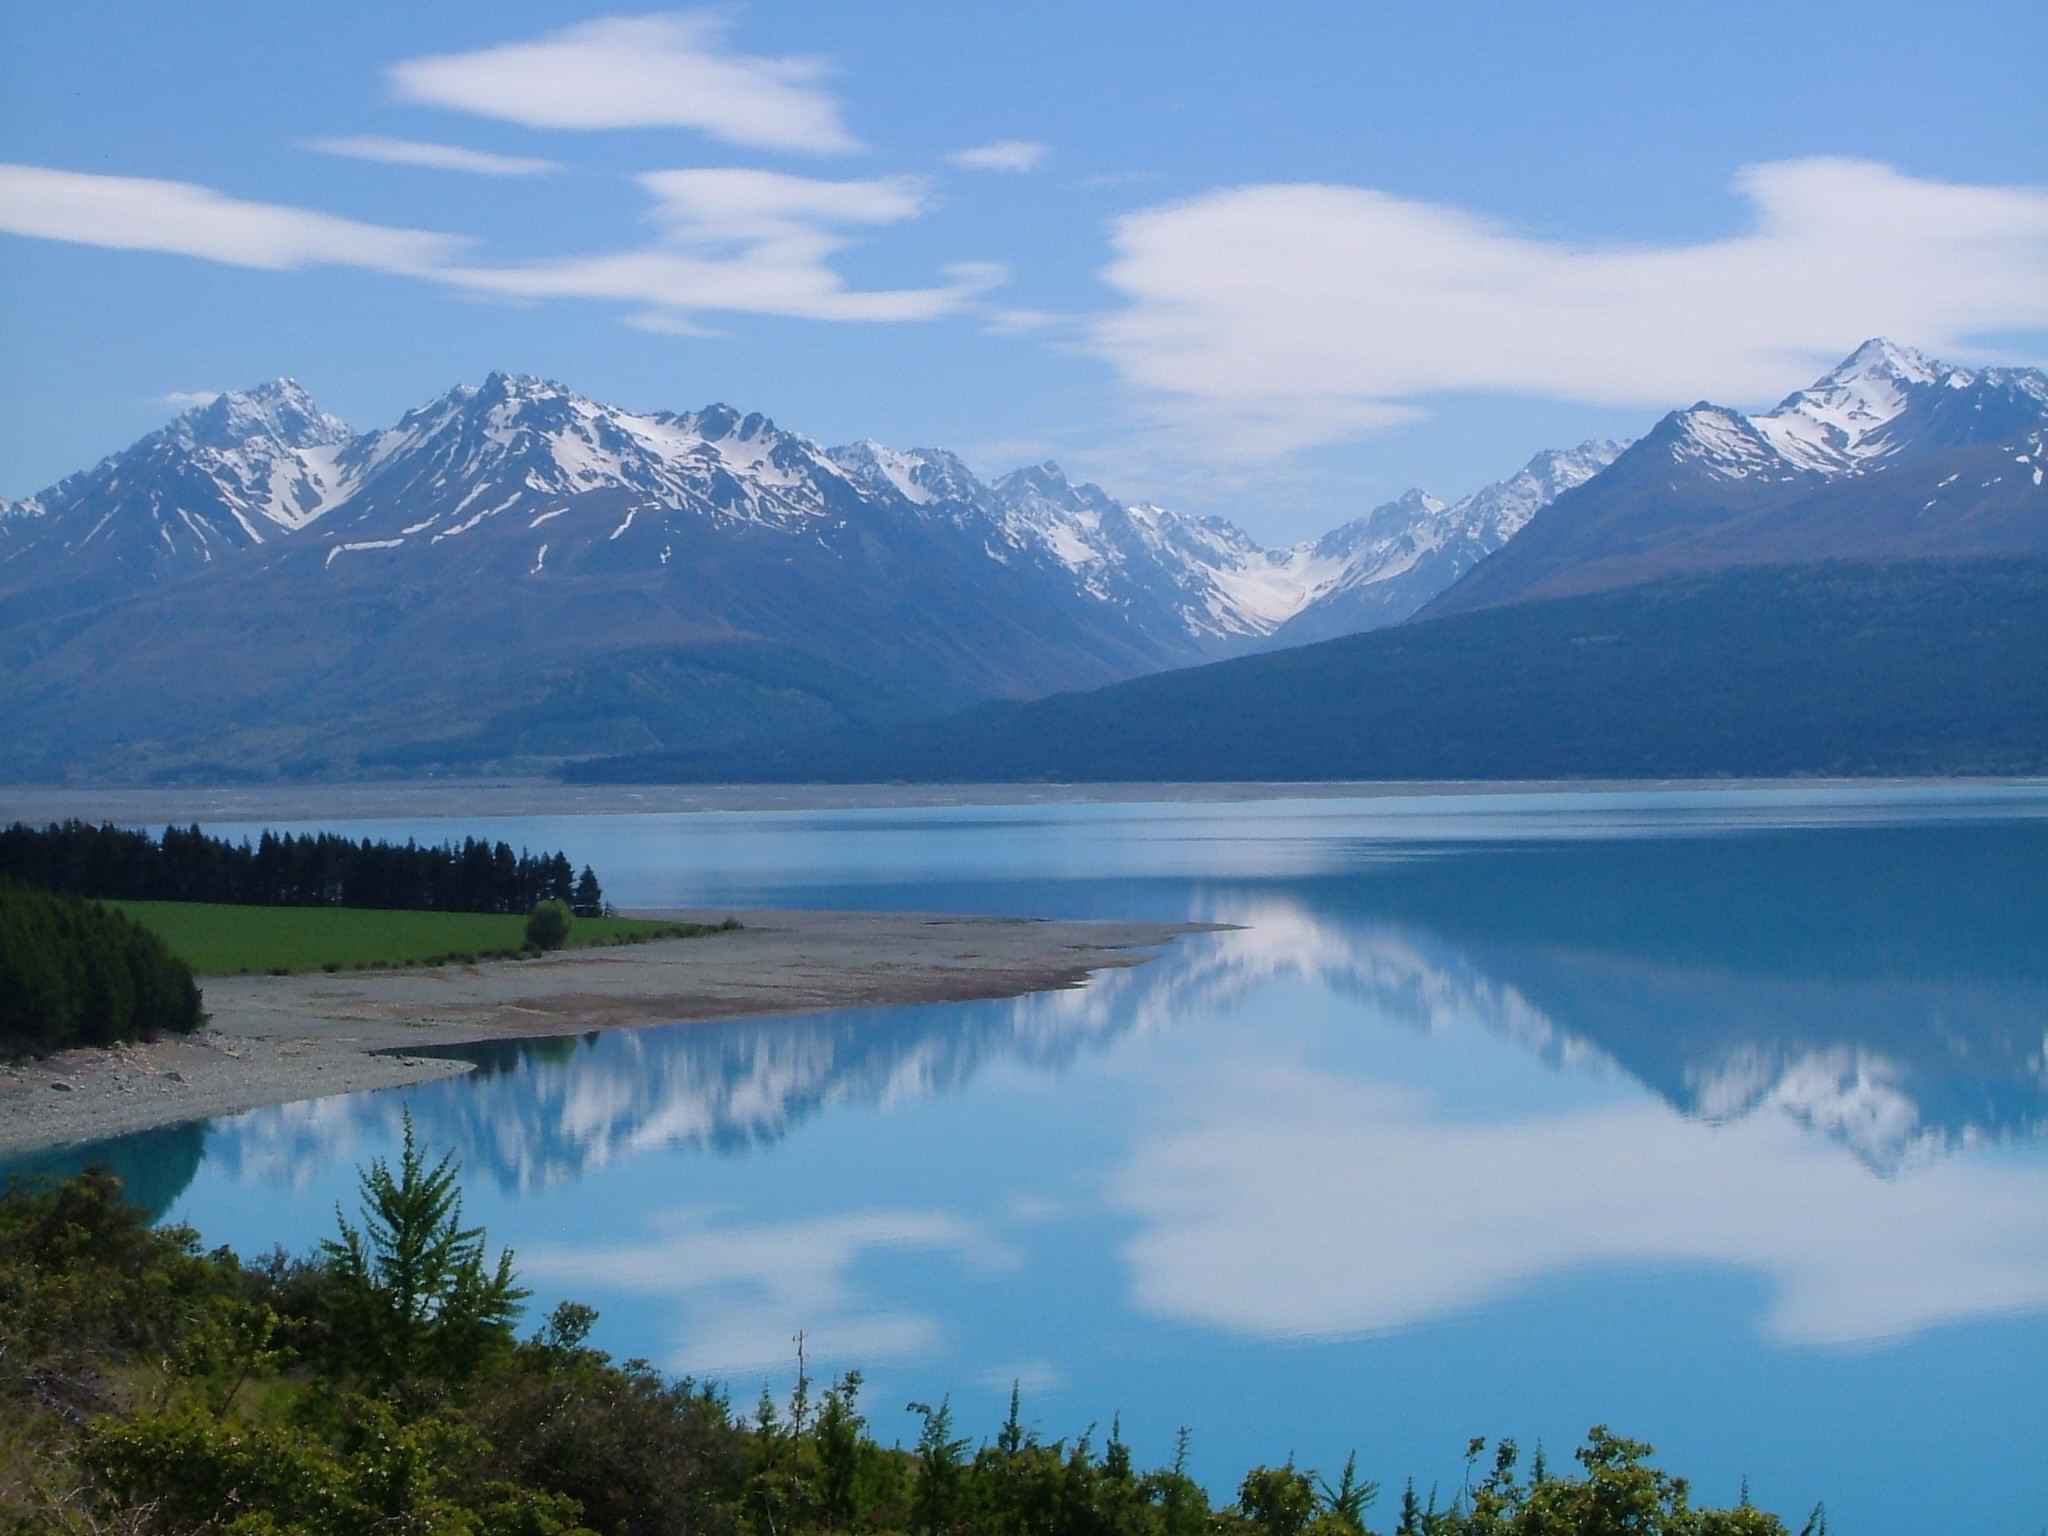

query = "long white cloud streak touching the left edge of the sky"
[0,164,463,274]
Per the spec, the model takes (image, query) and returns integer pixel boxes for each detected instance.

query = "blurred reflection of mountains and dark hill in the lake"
[213,829,2048,1188]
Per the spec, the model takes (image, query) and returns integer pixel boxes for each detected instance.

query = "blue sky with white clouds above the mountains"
[0,2,2048,539]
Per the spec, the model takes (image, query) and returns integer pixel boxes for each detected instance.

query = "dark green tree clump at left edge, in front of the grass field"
[0,879,203,1055]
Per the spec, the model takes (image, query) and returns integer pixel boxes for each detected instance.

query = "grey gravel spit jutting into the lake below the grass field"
[0,911,1214,1155]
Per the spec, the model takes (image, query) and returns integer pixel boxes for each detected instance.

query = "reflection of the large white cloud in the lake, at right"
[1116,1069,2048,1346]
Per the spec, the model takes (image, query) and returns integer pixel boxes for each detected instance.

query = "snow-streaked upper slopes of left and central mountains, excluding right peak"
[0,373,1622,670]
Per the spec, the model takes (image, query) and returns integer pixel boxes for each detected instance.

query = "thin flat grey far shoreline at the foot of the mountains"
[0,776,2048,825]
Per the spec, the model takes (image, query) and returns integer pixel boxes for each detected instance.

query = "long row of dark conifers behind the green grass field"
[0,819,604,918]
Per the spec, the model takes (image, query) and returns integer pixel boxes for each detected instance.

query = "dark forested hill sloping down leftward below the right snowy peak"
[573,559,2048,782]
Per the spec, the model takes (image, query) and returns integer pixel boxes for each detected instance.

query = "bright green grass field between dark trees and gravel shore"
[104,901,733,977]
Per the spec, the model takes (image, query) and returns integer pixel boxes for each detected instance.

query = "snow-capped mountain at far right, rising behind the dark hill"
[1423,338,2048,616]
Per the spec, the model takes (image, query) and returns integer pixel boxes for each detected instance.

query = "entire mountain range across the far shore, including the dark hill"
[0,340,2048,778]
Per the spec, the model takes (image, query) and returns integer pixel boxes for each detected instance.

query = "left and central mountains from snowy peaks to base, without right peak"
[0,373,1620,776]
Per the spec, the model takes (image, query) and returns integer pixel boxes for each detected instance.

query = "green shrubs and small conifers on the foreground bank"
[0,1118,1827,1536]
